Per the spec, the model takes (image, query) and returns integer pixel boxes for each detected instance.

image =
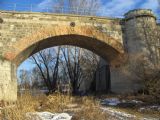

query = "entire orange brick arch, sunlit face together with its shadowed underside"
[4,26,124,65]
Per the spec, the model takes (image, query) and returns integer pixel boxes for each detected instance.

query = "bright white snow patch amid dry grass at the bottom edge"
[26,112,72,120]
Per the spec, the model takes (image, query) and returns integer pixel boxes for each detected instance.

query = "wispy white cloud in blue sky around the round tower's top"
[102,0,158,17]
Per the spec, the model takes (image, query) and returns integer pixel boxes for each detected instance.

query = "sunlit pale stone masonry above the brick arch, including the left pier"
[0,11,123,101]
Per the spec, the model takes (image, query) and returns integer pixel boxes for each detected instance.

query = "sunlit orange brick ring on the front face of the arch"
[4,26,124,64]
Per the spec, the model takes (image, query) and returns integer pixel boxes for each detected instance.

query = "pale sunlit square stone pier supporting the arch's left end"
[0,60,17,102]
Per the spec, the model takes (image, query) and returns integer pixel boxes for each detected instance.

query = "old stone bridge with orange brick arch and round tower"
[0,10,159,101]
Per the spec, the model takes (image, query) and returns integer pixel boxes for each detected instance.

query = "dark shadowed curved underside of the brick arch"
[10,34,122,65]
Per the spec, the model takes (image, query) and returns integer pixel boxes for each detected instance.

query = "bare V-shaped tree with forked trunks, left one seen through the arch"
[31,47,60,92]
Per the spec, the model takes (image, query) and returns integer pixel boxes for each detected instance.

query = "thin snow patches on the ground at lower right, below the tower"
[101,98,160,120]
